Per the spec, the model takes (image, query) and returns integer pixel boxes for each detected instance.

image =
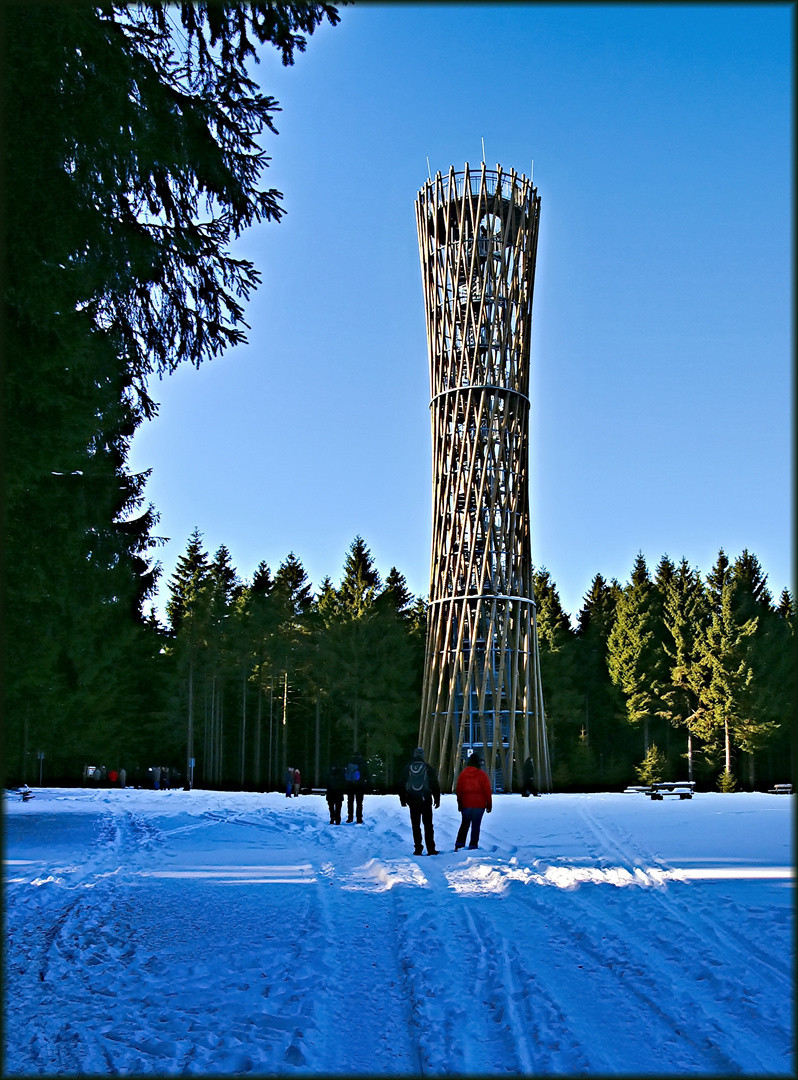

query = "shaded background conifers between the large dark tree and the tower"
[162,530,425,788]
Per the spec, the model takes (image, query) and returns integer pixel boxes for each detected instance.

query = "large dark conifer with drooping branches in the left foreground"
[2,3,338,779]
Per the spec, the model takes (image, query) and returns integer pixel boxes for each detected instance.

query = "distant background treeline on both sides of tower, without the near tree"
[11,518,795,791]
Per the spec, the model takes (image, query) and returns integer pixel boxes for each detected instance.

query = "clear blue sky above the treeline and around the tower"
[131,3,794,616]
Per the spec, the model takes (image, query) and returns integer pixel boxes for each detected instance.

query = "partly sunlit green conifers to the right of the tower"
[535,550,796,791]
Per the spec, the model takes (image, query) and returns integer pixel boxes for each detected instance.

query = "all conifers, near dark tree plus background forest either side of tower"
[2,3,795,791]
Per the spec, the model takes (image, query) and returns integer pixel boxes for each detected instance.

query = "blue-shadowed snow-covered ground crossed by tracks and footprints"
[3,788,795,1076]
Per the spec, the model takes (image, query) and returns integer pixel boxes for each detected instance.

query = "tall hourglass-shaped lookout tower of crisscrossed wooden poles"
[416,163,551,789]
